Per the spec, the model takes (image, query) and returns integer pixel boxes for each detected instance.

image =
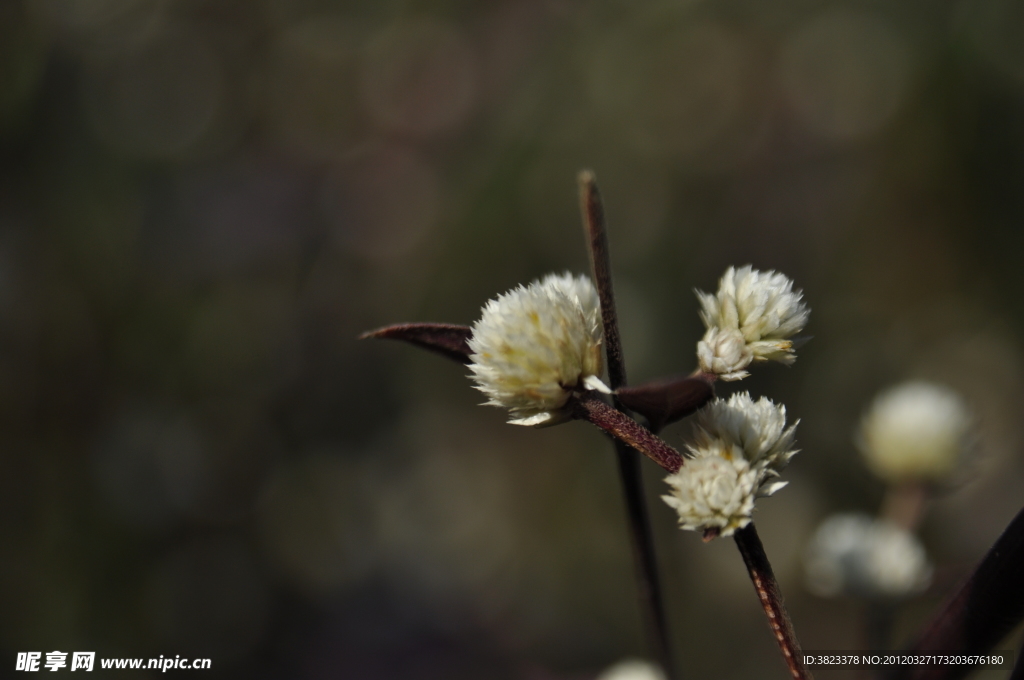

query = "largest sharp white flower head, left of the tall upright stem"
[469,272,607,425]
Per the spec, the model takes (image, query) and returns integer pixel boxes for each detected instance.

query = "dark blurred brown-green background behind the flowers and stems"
[0,0,1024,680]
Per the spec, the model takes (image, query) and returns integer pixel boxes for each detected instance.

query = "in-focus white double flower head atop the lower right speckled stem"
[662,392,797,536]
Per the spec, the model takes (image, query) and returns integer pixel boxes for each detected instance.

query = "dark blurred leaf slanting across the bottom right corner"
[893,501,1024,680]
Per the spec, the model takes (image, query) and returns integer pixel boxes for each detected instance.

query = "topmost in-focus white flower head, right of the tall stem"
[696,265,810,380]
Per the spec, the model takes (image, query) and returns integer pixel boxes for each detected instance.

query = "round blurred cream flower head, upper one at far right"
[857,381,972,481]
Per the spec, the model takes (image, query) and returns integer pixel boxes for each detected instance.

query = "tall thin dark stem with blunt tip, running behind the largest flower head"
[579,170,680,680]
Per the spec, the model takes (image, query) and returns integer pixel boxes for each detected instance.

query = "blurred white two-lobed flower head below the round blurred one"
[804,513,932,598]
